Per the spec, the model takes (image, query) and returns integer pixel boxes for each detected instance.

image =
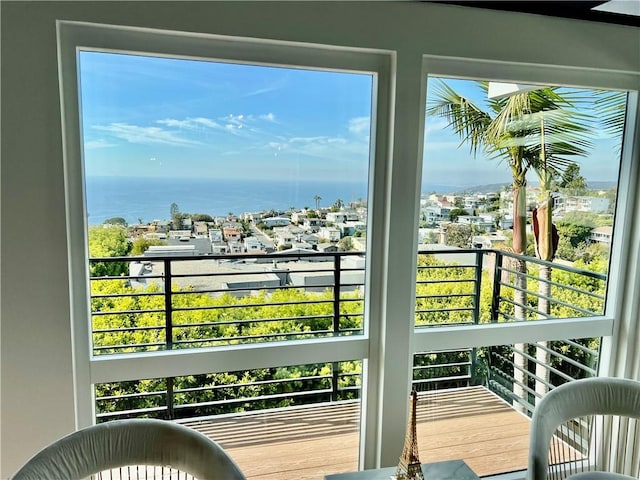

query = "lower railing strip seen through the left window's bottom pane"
[95,362,361,422]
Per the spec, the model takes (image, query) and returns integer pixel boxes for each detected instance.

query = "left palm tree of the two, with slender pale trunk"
[427,81,596,408]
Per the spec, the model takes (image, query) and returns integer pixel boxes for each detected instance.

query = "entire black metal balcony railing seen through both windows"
[90,249,606,421]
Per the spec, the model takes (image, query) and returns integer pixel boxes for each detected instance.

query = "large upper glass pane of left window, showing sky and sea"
[79,51,373,354]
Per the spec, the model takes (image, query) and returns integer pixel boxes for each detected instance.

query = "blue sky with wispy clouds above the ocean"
[80,52,617,186]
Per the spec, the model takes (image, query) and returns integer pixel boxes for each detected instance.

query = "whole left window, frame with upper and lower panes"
[63,20,388,478]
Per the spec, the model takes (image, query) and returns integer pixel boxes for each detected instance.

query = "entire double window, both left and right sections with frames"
[60,22,632,478]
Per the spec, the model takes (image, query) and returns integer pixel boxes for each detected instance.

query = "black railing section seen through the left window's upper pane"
[90,252,364,354]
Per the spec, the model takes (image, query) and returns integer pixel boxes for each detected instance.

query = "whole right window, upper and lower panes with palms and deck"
[413,70,627,475]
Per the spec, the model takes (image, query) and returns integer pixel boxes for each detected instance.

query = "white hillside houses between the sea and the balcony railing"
[132,191,610,255]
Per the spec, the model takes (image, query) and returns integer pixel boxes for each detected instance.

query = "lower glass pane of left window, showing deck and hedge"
[95,361,362,480]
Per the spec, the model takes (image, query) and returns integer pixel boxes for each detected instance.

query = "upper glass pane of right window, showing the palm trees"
[416,77,626,326]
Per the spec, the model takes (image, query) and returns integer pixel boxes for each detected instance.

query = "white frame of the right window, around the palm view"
[415,55,638,352]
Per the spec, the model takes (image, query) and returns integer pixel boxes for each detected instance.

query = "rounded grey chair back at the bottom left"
[12,419,245,480]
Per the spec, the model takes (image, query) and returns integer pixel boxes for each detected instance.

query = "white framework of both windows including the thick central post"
[58,21,640,476]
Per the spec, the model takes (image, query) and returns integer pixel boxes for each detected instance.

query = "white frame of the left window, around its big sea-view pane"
[57,21,393,463]
